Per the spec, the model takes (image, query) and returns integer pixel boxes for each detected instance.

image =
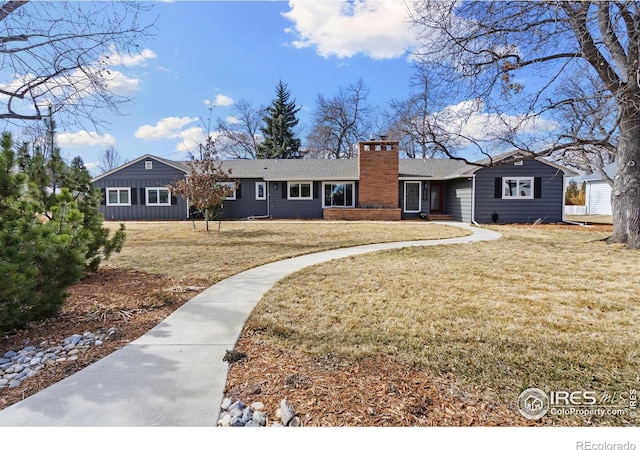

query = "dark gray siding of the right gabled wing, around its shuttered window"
[475,160,564,223]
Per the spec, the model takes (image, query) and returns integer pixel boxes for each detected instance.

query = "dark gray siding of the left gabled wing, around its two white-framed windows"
[94,159,187,220]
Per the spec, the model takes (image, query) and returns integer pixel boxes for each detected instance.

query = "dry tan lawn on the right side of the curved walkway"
[245,226,640,425]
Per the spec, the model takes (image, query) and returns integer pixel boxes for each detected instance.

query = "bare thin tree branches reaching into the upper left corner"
[0,1,150,129]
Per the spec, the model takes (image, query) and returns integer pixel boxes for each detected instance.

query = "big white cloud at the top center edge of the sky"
[283,0,416,59]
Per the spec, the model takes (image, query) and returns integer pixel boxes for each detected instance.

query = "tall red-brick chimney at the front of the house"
[358,141,399,208]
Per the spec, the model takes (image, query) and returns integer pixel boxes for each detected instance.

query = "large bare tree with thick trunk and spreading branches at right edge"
[412,0,640,249]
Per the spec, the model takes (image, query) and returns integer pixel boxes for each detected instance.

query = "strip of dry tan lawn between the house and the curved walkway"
[105,221,468,284]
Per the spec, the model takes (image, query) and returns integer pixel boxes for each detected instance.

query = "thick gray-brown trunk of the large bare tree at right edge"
[609,101,640,249]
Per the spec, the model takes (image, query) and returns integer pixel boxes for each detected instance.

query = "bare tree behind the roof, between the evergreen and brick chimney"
[307,79,373,159]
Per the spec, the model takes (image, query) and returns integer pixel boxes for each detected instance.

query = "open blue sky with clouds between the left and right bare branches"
[48,0,420,173]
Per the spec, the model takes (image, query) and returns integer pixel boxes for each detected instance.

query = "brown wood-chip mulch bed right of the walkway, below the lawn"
[225,335,542,427]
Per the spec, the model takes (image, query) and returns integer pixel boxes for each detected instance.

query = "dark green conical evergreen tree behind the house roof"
[256,80,302,159]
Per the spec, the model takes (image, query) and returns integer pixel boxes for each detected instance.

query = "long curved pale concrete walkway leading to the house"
[0,222,500,427]
